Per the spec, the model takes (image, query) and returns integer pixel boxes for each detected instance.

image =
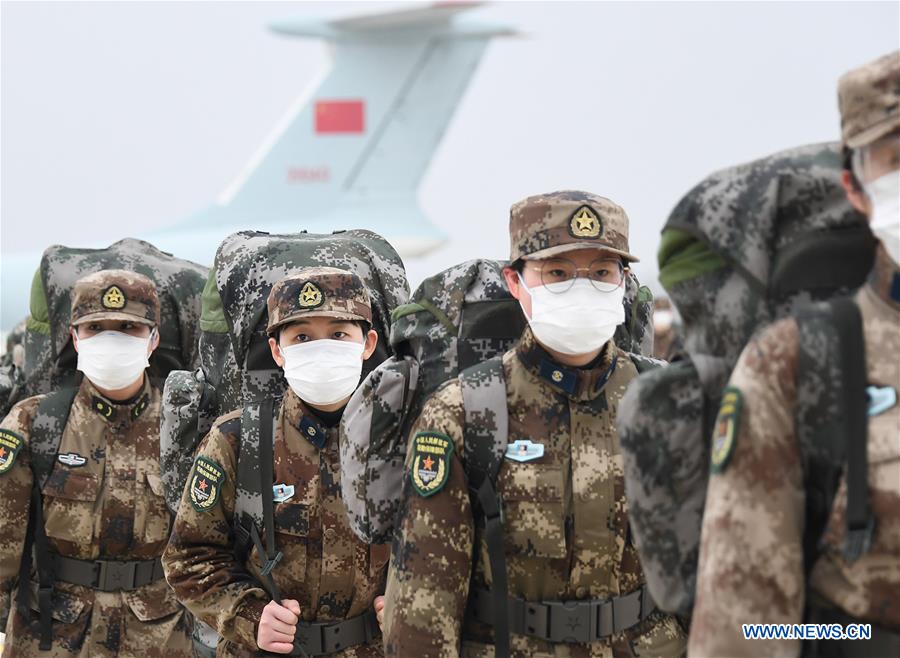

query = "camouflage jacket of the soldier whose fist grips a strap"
[163,390,389,658]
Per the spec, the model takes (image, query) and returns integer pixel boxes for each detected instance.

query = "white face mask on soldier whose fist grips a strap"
[279,338,365,406]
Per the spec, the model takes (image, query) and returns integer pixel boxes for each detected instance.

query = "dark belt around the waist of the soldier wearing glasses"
[469,586,656,643]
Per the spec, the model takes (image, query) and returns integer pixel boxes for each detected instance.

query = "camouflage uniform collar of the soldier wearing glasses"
[516,328,618,400]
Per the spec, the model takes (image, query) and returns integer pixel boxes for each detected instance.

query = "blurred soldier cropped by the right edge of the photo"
[689,52,900,656]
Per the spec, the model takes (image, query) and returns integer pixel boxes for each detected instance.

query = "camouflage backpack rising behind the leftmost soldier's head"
[23,238,207,396]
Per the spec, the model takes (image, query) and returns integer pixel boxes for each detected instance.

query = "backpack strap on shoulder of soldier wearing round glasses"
[459,356,509,658]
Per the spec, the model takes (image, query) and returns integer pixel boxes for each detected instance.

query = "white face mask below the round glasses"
[519,274,625,355]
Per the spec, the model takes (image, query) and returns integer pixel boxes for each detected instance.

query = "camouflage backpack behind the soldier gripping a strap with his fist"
[160,230,409,516]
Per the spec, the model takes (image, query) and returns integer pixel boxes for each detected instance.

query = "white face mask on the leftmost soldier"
[75,331,155,391]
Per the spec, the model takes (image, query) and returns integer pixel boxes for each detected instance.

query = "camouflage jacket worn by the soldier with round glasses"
[385,329,685,658]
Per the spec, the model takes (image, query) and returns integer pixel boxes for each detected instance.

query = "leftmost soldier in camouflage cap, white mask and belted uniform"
[0,270,192,658]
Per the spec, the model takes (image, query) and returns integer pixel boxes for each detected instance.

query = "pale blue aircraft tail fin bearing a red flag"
[183,3,512,255]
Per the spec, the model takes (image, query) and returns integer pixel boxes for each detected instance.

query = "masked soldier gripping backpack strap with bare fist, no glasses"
[164,267,390,658]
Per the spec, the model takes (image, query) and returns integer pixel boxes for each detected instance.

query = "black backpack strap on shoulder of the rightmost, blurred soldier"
[795,298,874,571]
